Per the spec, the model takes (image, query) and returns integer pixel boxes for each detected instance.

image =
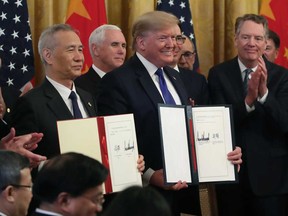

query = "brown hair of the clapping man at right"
[235,14,268,38]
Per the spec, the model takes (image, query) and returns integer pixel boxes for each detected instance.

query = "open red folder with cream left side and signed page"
[57,114,142,193]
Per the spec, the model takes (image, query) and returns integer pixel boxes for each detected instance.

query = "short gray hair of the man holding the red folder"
[38,24,78,64]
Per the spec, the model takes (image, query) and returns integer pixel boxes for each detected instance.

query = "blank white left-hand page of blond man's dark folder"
[160,107,192,183]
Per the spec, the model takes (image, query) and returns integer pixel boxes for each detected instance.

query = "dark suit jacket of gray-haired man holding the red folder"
[12,79,96,158]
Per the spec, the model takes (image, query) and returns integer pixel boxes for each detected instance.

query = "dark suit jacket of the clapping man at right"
[208,57,288,196]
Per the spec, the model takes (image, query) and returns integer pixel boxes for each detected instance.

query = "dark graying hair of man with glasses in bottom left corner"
[0,150,30,190]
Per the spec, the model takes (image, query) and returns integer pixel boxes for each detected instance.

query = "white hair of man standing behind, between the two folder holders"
[89,24,121,55]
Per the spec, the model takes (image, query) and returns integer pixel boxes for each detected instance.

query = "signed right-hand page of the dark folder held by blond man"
[192,107,235,182]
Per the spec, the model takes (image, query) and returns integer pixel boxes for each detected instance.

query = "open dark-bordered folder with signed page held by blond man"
[159,105,238,184]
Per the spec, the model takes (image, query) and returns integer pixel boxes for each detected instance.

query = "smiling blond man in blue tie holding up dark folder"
[98,11,241,215]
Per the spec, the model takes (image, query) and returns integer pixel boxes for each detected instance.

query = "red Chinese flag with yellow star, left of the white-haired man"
[66,0,107,72]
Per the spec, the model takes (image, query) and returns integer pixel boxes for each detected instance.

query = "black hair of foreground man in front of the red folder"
[33,152,108,203]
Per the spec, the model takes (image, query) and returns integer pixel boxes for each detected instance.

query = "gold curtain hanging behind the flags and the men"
[27,0,261,84]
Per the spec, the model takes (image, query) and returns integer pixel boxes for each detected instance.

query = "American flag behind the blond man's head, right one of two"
[156,0,199,71]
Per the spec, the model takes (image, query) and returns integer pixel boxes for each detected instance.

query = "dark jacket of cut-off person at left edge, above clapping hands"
[0,86,21,139]
